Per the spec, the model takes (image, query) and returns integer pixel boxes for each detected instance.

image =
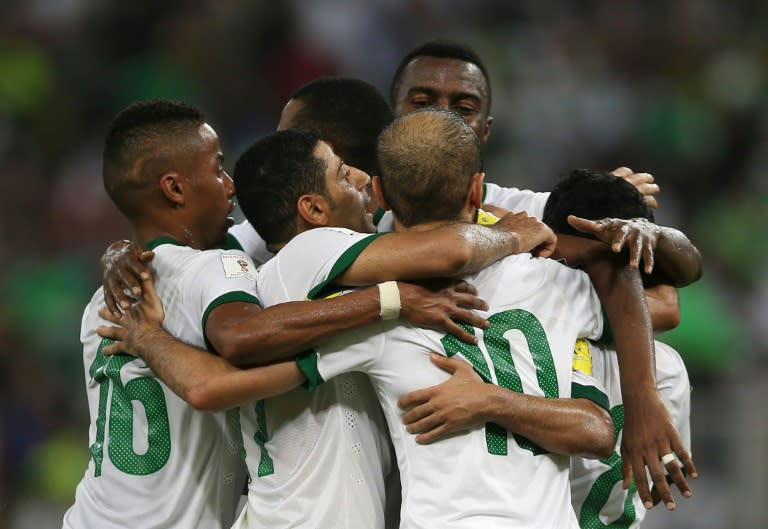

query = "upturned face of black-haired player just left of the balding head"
[314,141,376,233]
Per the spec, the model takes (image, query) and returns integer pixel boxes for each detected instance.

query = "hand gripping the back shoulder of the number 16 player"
[101,241,155,314]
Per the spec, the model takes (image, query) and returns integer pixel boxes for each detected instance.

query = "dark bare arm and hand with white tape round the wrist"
[205,281,488,365]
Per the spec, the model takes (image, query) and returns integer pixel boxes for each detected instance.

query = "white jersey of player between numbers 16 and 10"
[235,228,391,529]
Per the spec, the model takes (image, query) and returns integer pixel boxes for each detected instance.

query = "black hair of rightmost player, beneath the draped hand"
[542,169,653,237]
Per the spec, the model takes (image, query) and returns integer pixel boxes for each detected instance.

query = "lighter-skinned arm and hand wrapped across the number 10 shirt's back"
[398,353,616,459]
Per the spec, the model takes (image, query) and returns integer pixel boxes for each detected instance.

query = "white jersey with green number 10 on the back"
[298,249,607,529]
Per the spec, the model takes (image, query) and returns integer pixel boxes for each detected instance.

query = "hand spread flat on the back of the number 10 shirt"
[397,353,488,444]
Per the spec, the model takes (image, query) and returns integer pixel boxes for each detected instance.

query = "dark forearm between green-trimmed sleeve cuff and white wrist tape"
[216,287,381,366]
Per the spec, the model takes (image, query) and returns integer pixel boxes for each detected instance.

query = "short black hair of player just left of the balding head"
[233,129,327,244]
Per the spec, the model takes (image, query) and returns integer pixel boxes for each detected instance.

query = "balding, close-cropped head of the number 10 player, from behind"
[374,108,483,228]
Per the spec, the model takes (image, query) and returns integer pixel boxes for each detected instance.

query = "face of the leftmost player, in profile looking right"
[185,123,235,248]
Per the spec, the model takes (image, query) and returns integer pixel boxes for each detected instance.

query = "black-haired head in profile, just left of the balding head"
[234,129,375,248]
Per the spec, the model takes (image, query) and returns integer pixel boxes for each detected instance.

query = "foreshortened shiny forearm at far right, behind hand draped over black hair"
[655,227,702,287]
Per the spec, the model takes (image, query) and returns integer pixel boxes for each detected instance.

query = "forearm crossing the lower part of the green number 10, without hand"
[486,385,616,459]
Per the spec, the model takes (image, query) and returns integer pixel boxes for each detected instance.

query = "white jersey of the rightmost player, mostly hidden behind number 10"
[571,341,691,529]
